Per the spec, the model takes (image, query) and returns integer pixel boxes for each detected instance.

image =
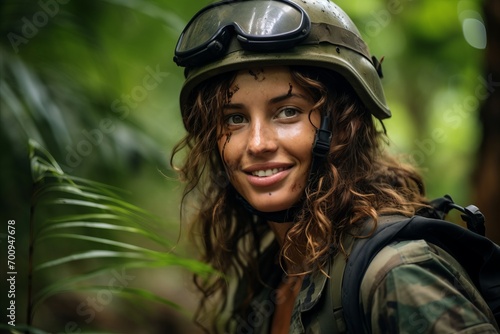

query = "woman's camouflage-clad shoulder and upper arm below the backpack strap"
[360,240,496,333]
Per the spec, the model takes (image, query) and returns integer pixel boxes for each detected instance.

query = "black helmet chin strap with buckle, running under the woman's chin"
[230,115,332,223]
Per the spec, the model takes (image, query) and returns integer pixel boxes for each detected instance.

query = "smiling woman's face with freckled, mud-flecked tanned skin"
[218,67,320,212]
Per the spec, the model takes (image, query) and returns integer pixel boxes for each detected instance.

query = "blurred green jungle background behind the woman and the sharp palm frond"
[0,0,498,333]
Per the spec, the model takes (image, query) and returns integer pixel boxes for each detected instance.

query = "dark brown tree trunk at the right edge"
[474,0,500,243]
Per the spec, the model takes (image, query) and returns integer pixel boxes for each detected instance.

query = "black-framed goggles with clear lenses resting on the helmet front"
[174,0,311,66]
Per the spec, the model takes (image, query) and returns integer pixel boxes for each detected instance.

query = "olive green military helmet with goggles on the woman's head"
[174,0,391,123]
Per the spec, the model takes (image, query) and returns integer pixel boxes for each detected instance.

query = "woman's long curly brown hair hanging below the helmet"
[171,67,428,332]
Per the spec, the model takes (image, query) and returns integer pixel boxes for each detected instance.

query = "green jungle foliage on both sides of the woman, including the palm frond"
[0,0,487,333]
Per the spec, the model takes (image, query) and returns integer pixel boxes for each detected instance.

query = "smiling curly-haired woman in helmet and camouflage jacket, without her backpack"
[172,0,495,333]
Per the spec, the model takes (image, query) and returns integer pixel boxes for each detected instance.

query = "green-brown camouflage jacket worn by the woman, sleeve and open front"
[232,240,499,334]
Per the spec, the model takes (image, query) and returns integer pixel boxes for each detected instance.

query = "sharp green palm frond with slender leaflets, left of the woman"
[23,140,217,325]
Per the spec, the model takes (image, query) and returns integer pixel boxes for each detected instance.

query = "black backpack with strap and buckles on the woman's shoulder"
[329,195,500,333]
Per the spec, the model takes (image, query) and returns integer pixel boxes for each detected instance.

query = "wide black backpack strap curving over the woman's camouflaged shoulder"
[341,216,500,333]
